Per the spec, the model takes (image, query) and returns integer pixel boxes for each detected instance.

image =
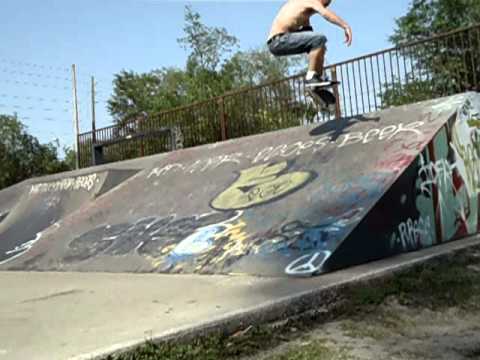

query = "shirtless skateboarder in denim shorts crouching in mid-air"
[267,0,352,90]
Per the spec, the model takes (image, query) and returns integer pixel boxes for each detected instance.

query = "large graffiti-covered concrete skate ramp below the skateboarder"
[0,93,480,276]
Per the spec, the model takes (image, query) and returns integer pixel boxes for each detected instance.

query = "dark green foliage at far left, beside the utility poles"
[0,115,70,189]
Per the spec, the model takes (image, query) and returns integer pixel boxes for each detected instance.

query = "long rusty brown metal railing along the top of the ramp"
[79,25,480,167]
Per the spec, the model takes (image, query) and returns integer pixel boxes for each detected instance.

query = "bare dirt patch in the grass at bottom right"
[274,299,480,360]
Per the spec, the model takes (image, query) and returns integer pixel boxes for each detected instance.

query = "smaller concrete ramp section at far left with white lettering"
[0,170,139,264]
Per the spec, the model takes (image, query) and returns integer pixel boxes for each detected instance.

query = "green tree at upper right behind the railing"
[381,0,480,106]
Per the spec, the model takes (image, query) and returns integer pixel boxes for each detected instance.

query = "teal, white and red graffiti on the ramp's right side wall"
[417,101,480,241]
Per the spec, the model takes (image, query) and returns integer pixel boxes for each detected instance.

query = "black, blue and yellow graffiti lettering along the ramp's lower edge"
[64,211,253,271]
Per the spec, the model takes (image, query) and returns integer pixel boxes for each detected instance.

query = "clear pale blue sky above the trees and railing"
[0,0,410,153]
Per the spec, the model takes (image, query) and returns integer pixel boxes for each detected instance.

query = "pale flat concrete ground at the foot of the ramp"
[0,237,480,360]
